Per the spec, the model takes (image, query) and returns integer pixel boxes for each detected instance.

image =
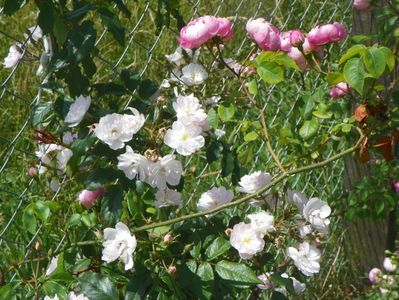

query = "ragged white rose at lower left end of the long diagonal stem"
[101,222,137,270]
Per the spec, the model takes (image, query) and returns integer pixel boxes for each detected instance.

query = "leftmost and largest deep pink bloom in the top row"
[179,16,233,49]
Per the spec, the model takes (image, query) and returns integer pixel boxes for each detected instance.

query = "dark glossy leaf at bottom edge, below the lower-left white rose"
[78,272,119,300]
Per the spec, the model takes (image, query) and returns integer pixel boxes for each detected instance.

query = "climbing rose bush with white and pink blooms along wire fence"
[0,0,399,299]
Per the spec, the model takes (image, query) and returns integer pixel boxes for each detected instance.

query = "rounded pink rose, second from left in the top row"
[246,18,281,51]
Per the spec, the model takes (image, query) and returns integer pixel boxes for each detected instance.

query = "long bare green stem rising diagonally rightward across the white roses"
[132,128,366,232]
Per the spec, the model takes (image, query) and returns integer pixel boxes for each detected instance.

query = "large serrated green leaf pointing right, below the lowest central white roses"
[215,260,261,286]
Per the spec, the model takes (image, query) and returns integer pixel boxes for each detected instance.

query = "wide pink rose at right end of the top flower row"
[307,22,347,46]
